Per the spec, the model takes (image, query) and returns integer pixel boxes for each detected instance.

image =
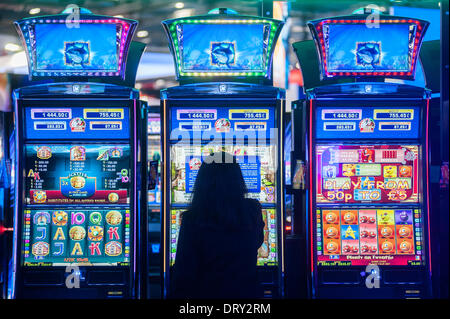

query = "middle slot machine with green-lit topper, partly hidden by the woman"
[161,8,284,297]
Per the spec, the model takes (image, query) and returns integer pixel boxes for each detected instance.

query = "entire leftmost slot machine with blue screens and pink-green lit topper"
[8,9,147,299]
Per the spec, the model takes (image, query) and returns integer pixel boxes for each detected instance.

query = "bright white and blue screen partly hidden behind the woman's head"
[170,144,276,204]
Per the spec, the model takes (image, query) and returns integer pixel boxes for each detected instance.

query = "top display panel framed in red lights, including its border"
[308,15,429,79]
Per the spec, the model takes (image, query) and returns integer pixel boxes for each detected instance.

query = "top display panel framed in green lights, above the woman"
[163,15,283,78]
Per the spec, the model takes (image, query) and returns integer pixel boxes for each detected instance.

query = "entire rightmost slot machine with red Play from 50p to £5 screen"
[293,12,431,299]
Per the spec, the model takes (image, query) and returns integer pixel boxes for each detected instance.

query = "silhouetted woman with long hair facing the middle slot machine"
[169,152,264,299]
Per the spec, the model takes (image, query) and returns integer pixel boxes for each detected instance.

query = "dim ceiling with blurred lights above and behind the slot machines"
[0,0,445,52]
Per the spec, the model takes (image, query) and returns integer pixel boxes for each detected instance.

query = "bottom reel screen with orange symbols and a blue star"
[316,208,424,266]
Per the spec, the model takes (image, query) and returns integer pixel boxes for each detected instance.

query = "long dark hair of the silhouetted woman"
[187,152,250,229]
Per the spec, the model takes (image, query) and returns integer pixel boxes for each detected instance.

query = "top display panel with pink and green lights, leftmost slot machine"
[16,15,137,79]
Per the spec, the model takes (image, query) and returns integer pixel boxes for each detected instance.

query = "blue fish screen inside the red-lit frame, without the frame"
[323,23,412,72]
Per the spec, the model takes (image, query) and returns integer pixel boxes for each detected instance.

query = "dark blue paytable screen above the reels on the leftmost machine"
[25,144,131,205]
